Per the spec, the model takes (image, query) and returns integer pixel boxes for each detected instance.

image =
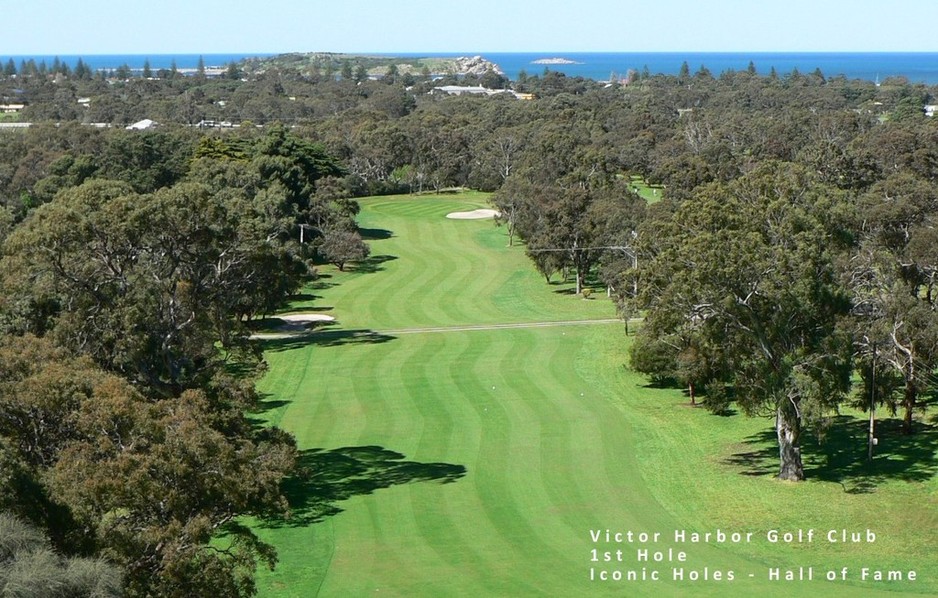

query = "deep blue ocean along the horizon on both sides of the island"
[0,51,938,85]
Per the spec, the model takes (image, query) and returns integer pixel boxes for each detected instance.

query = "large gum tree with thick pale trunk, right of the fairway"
[631,163,851,480]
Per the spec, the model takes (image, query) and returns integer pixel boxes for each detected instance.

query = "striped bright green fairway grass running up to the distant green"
[249,194,938,597]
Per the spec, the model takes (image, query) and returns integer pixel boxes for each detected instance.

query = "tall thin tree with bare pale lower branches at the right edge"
[844,173,938,433]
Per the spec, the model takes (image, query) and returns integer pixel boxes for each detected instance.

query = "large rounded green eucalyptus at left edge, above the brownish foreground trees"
[2,180,306,396]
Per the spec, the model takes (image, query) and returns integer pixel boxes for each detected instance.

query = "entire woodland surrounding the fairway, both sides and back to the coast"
[0,58,938,596]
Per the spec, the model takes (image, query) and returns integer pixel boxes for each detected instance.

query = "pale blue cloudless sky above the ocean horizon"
[0,0,938,56]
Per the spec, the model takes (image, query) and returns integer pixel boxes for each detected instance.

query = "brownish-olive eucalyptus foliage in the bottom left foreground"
[0,335,294,597]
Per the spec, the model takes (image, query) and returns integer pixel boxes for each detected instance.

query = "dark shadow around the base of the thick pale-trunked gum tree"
[725,415,938,494]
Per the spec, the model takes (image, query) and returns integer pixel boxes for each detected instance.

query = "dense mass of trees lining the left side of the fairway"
[0,125,354,596]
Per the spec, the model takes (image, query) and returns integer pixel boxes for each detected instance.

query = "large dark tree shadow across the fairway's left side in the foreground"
[264,446,466,527]
